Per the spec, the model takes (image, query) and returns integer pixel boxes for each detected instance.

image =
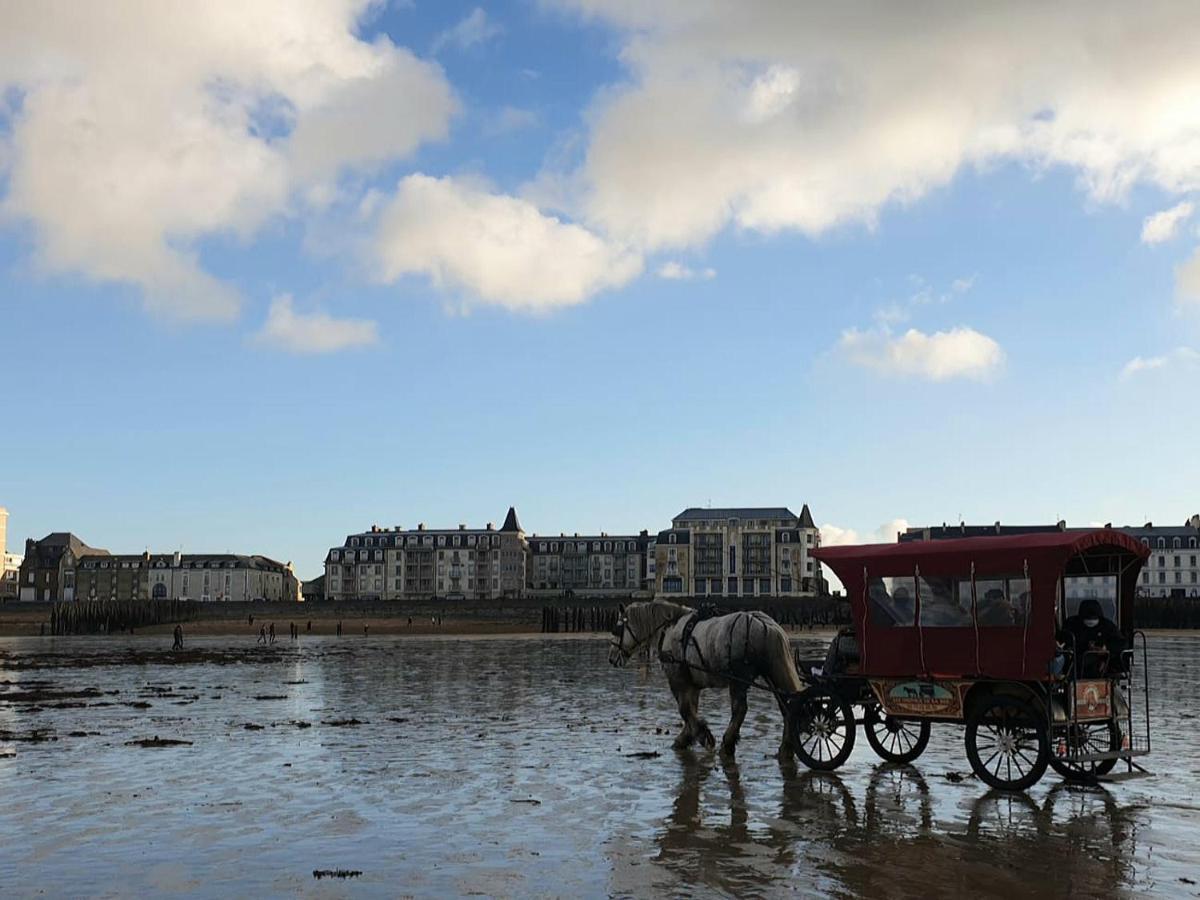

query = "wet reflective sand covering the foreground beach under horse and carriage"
[0,624,1200,898]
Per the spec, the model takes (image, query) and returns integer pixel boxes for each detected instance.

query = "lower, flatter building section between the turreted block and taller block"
[526,532,650,598]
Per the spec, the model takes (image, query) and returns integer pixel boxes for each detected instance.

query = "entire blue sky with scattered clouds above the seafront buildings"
[0,0,1200,577]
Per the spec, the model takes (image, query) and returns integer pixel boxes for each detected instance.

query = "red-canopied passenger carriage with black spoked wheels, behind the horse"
[790,529,1150,790]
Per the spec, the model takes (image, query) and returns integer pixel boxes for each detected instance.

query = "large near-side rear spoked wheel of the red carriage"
[966,694,1050,791]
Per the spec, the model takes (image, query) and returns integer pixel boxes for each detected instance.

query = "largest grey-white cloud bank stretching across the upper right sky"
[560,0,1200,250]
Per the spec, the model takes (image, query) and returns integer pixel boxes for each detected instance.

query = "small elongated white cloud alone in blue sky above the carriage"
[838,326,1004,382]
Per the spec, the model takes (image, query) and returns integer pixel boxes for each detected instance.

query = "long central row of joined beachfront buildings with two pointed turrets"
[323,506,824,600]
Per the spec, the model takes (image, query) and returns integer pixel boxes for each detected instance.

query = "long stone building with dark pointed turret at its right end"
[325,506,528,600]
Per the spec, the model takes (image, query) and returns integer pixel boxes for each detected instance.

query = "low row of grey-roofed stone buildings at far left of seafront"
[18,532,300,602]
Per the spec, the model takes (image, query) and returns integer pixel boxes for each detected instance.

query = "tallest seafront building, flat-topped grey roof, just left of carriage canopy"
[654,504,824,599]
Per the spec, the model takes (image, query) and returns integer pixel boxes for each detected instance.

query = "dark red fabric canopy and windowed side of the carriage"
[814,528,1150,679]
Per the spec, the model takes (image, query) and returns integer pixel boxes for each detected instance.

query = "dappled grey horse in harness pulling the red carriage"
[608,600,805,760]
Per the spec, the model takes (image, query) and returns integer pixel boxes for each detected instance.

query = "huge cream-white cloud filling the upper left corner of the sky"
[0,0,455,318]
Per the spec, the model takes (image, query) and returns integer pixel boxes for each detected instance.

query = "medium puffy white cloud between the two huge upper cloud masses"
[374,175,642,312]
